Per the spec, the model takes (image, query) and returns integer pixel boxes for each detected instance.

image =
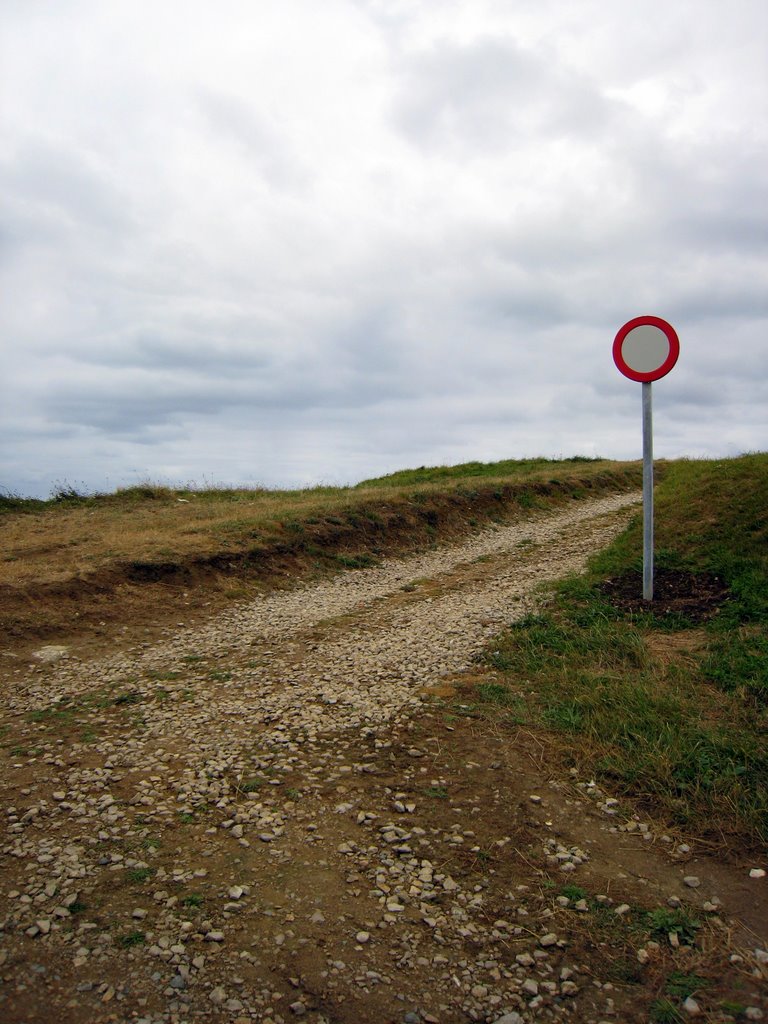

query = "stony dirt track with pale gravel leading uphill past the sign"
[0,495,766,1024]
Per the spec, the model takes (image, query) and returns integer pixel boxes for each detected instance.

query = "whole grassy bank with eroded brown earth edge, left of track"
[0,457,640,640]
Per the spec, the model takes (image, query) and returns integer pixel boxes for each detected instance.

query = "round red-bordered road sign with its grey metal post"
[613,316,680,601]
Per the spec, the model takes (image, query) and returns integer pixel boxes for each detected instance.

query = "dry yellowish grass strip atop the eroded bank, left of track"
[0,462,638,587]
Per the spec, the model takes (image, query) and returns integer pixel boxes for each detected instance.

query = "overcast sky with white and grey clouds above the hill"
[0,0,768,497]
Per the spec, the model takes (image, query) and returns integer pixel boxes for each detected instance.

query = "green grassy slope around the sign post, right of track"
[477,454,768,852]
